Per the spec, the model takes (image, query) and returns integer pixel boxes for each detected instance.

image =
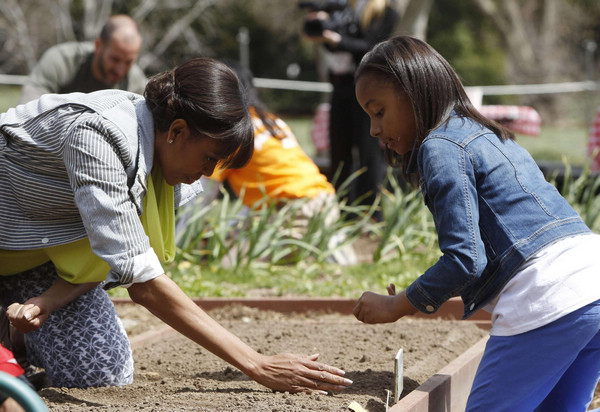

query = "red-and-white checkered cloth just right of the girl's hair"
[479,105,542,136]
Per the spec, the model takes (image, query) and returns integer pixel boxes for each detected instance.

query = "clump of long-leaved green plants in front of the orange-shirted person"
[176,173,377,269]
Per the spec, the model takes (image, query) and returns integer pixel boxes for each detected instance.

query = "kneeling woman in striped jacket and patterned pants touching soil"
[0,58,350,392]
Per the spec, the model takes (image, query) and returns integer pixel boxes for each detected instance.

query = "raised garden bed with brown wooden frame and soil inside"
[31,298,600,412]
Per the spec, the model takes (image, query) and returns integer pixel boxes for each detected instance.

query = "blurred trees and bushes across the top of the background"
[0,0,600,117]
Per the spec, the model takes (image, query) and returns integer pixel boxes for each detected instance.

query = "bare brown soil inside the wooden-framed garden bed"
[40,305,487,412]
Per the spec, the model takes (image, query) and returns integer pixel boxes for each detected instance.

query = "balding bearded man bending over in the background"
[19,15,146,103]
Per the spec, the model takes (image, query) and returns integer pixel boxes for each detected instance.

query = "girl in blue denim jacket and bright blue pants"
[354,36,600,411]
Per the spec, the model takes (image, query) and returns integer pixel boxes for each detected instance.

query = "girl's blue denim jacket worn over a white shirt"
[406,116,590,318]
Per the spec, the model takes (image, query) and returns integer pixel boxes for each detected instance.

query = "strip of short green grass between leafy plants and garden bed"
[110,248,439,298]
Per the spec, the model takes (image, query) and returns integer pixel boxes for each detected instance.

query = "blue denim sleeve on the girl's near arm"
[406,138,487,313]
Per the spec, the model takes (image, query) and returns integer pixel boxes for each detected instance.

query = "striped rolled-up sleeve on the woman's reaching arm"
[64,116,164,285]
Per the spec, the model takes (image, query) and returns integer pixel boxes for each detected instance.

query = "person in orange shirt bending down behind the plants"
[185,61,356,264]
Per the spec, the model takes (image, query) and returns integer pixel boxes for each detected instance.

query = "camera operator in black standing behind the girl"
[303,0,399,220]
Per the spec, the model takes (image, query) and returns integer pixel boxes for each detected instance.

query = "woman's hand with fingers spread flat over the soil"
[253,353,352,395]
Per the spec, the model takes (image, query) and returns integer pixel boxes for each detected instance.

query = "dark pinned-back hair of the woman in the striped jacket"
[144,57,254,168]
